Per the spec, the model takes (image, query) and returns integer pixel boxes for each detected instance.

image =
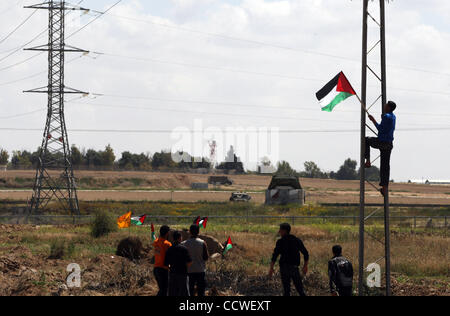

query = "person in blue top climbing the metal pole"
[365,101,397,195]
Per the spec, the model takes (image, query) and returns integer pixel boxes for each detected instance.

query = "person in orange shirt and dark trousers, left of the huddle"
[153,226,172,296]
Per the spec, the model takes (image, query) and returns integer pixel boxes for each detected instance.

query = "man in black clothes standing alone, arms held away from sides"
[269,223,309,296]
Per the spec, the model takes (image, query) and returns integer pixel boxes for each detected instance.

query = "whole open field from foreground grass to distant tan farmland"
[0,171,450,296]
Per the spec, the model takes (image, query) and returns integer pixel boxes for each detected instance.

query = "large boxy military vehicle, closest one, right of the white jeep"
[266,176,306,205]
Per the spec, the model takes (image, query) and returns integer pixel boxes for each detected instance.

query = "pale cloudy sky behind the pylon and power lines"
[0,0,450,181]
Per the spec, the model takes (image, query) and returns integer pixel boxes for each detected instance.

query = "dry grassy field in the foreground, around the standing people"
[0,202,450,295]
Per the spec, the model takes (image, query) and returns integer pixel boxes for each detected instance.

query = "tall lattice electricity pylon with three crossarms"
[24,0,87,215]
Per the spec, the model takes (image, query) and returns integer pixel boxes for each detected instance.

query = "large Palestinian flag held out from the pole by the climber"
[316,71,356,112]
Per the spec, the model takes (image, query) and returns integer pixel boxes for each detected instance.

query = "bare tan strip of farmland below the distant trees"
[0,171,450,205]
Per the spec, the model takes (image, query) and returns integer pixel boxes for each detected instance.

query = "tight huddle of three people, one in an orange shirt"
[153,225,209,297]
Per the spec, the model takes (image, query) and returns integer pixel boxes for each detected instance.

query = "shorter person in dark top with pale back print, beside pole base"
[328,245,353,296]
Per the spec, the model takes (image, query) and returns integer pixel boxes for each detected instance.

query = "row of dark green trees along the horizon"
[0,145,379,181]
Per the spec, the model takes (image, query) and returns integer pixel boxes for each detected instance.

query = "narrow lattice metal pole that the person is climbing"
[358,0,391,296]
